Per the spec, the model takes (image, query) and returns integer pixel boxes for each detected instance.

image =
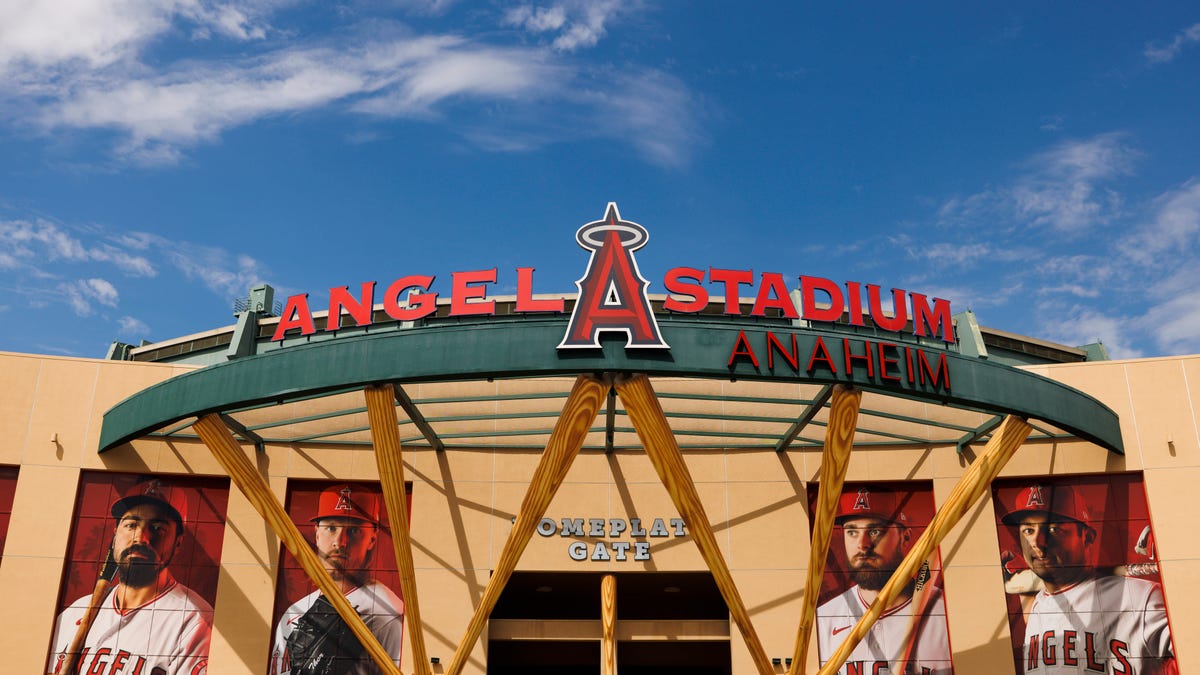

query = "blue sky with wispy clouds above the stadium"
[0,0,1200,358]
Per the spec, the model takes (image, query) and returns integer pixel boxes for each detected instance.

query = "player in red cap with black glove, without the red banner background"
[269,484,404,675]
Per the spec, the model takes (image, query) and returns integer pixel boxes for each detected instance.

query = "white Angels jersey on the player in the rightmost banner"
[1022,577,1176,675]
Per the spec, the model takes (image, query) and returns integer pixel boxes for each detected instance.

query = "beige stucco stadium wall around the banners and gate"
[0,353,1200,675]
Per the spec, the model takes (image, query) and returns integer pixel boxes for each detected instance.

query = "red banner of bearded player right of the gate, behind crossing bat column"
[816,484,953,675]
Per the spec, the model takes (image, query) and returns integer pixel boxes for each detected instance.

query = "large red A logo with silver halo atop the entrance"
[558,202,671,350]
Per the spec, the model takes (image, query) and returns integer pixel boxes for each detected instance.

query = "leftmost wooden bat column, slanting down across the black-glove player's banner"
[192,413,401,675]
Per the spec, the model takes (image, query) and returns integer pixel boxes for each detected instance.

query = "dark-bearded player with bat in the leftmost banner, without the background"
[49,478,227,675]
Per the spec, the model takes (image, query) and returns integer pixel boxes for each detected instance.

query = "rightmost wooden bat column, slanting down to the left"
[820,414,1033,675]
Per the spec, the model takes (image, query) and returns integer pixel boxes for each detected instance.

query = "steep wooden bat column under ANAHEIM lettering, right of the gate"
[791,384,863,675]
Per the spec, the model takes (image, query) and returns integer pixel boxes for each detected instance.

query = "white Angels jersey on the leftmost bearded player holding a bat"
[53,580,212,675]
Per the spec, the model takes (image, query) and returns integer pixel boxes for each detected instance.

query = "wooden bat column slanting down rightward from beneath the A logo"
[616,375,775,675]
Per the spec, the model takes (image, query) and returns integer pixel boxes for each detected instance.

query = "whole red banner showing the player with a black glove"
[268,480,410,675]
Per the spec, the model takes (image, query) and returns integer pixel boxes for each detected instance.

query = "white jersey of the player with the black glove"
[268,581,404,675]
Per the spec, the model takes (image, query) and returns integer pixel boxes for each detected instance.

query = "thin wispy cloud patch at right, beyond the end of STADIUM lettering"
[888,133,1200,358]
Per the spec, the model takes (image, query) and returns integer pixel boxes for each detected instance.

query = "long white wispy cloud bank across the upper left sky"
[0,0,697,166]
